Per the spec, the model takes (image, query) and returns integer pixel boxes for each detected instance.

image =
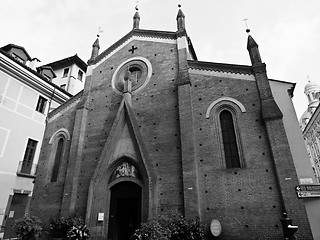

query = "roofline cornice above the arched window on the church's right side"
[188,60,254,75]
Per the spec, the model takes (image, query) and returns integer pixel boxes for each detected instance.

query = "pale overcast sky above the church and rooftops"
[0,0,320,117]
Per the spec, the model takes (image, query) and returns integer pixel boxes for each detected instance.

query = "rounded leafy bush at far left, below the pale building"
[14,216,42,240]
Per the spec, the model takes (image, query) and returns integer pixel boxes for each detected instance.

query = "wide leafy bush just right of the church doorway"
[131,216,204,240]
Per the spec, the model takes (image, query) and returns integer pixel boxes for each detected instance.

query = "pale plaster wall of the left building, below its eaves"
[0,68,48,227]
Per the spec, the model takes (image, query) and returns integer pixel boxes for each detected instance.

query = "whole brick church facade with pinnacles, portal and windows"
[30,6,313,240]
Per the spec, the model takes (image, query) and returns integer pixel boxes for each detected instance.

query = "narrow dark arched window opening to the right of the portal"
[220,110,241,168]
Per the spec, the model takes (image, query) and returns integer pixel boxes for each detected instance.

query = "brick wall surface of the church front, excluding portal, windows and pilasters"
[31,38,312,240]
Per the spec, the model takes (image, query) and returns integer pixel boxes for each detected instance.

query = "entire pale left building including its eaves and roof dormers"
[0,44,73,239]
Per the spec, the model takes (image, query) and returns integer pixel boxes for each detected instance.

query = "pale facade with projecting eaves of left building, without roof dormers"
[0,51,70,239]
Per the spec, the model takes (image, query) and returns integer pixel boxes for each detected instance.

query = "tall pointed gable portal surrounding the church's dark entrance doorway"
[86,95,155,240]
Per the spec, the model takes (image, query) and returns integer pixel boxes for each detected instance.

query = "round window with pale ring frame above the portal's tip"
[111,57,152,94]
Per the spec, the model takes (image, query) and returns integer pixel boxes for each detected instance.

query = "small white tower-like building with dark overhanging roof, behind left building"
[38,54,87,95]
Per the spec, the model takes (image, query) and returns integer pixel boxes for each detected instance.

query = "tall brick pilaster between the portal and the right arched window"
[177,31,200,218]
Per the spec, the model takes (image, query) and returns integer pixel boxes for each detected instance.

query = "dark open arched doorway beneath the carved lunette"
[108,181,142,240]
